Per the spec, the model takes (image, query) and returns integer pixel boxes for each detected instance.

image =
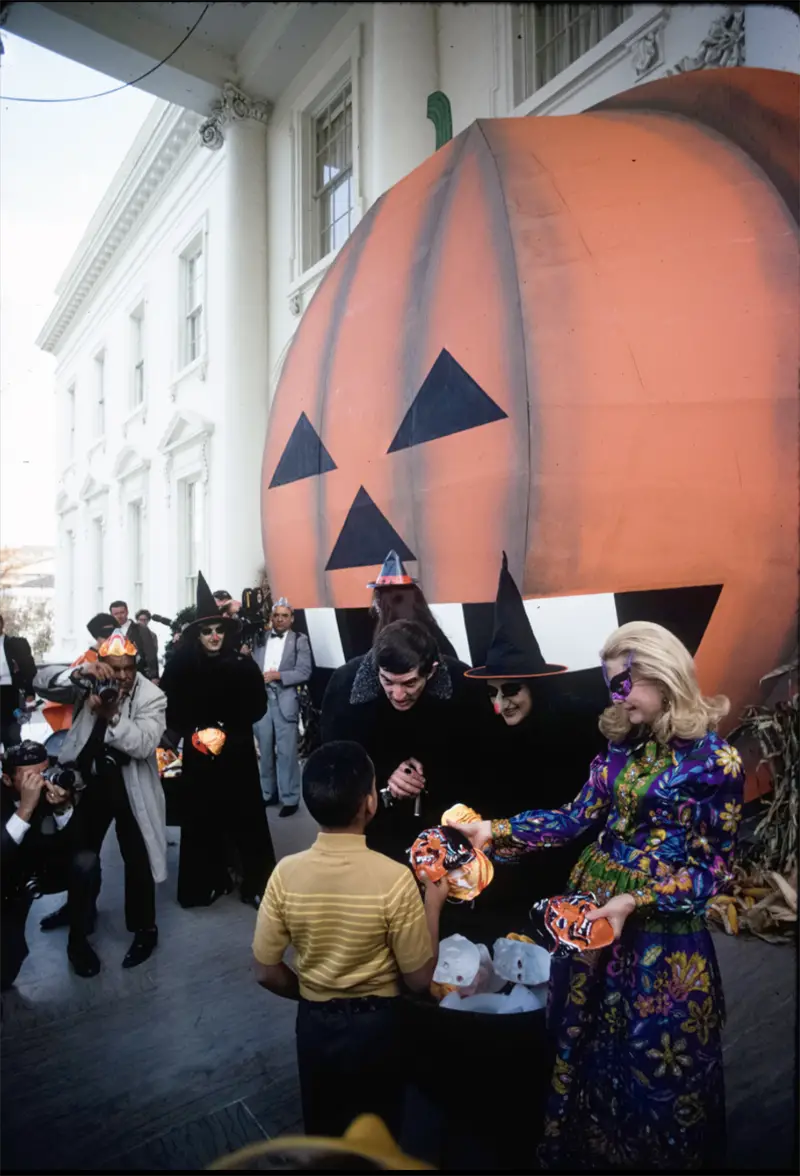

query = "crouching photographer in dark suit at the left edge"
[0,740,99,991]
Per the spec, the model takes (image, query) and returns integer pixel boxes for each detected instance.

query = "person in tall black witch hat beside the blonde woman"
[465,552,605,942]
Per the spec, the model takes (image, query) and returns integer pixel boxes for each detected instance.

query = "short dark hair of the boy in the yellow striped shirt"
[302,740,375,829]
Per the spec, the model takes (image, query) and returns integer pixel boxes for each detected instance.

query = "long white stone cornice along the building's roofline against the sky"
[36,106,202,354]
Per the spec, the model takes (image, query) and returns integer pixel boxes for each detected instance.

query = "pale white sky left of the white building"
[0,33,154,547]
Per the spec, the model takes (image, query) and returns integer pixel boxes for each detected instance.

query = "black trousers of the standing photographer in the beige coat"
[75,770,155,934]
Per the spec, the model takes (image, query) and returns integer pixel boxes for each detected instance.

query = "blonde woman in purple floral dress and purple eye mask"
[449,622,742,1169]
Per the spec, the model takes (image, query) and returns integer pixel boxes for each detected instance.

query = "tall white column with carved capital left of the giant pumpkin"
[212,100,269,594]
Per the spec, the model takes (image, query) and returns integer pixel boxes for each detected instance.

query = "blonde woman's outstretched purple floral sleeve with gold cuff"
[492,756,611,861]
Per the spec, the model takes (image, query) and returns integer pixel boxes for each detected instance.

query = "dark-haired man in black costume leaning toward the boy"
[322,621,494,863]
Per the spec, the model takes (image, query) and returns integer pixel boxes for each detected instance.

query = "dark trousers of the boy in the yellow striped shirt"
[296,997,405,1138]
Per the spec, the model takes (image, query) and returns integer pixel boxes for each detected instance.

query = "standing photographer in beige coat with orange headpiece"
[41,633,167,969]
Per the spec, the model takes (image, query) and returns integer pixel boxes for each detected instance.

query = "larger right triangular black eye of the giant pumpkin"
[386,350,508,453]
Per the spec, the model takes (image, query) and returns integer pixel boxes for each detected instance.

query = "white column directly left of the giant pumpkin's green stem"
[371,4,439,199]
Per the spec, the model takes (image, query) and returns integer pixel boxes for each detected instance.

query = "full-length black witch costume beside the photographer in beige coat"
[161,574,275,907]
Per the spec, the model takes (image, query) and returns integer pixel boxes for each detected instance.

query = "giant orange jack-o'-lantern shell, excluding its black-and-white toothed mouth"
[262,68,800,724]
